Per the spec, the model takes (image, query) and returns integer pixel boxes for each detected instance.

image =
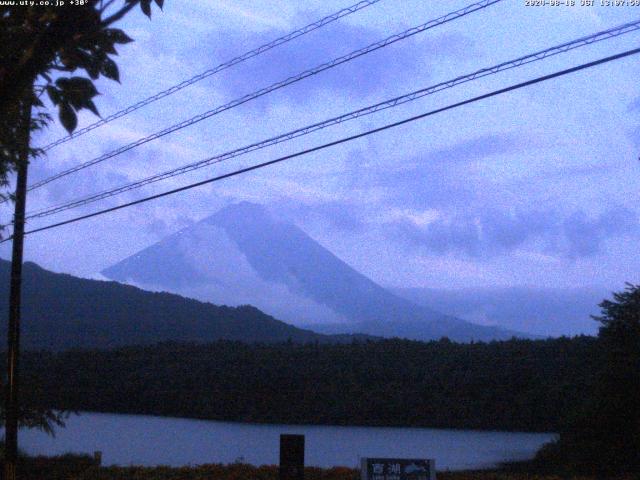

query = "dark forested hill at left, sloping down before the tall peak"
[0,260,364,350]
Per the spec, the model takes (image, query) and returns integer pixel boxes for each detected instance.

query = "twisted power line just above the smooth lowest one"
[27,20,640,219]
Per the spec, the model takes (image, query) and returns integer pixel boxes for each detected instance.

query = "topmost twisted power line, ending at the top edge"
[42,0,388,151]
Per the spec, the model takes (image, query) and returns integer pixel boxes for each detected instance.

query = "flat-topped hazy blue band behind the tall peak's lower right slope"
[392,287,611,337]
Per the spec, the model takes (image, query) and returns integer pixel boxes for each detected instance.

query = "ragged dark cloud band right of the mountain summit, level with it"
[388,206,640,259]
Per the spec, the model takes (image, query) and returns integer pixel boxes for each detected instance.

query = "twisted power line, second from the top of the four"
[29,0,502,190]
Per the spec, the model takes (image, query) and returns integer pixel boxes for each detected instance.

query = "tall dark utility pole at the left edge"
[4,94,31,480]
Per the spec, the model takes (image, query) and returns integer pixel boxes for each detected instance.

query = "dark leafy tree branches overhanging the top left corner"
[0,0,163,195]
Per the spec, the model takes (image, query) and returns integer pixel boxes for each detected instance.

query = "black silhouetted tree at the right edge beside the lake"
[539,284,640,473]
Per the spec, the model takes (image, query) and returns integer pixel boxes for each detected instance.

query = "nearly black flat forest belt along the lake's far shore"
[22,337,598,431]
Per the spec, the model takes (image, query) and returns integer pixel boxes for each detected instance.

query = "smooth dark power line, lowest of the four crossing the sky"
[6,48,640,243]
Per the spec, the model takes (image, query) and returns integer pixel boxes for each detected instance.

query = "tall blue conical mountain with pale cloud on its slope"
[102,202,523,341]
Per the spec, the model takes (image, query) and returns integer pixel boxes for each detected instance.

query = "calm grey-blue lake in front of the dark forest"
[18,412,554,470]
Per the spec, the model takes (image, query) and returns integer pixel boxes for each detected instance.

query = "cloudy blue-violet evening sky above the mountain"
[0,0,640,291]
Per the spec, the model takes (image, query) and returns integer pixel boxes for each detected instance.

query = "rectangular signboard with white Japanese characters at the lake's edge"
[361,458,436,480]
